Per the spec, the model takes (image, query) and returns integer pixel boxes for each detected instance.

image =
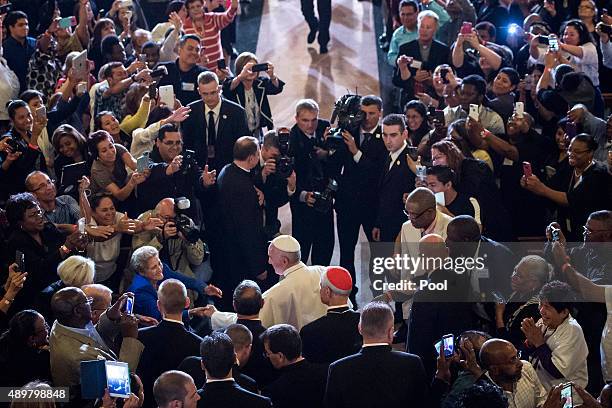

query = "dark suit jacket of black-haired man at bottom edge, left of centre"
[198,381,272,408]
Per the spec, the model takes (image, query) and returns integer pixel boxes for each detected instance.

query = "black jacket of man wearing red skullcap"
[300,307,362,364]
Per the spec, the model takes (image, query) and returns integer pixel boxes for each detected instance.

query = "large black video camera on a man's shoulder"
[325,94,365,150]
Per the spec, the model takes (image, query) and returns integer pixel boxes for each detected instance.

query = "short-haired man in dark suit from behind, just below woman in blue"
[137,279,202,407]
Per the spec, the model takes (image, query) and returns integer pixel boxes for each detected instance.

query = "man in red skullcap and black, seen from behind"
[300,266,362,364]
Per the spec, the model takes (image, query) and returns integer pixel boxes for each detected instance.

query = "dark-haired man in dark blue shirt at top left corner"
[3,11,36,93]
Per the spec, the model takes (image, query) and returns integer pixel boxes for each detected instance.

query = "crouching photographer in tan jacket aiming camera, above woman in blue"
[132,197,205,284]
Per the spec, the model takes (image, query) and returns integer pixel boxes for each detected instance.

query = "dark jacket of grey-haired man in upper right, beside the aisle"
[393,40,450,96]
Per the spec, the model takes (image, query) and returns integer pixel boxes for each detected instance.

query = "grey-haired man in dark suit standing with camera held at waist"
[289,99,337,265]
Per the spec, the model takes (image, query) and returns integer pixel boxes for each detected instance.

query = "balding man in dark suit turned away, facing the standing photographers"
[211,136,268,310]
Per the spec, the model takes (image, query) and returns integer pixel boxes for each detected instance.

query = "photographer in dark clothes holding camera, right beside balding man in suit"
[253,128,296,239]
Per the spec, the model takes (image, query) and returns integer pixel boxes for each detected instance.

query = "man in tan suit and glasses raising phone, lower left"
[49,287,144,387]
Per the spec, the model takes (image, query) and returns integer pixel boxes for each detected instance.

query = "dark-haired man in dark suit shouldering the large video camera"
[332,95,388,304]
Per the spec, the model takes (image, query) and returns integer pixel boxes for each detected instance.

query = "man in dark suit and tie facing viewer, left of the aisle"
[181,71,250,173]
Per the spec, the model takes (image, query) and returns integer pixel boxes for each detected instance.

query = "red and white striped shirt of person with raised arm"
[184,7,236,71]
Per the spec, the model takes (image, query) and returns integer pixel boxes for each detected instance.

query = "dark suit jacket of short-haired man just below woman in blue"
[137,320,202,407]
